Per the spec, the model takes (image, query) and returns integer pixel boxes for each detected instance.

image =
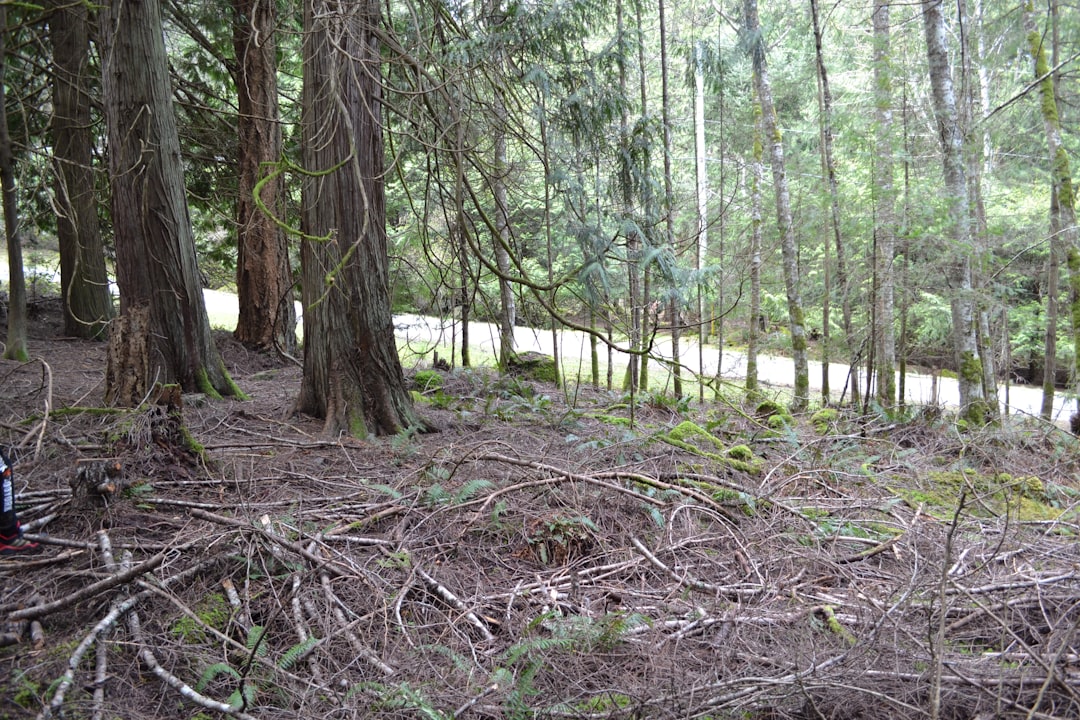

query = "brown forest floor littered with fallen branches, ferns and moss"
[0,295,1080,720]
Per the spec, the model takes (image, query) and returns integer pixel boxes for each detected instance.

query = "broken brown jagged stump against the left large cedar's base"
[105,305,150,407]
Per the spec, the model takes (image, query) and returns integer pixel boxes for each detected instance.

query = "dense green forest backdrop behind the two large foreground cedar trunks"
[4,2,1080,427]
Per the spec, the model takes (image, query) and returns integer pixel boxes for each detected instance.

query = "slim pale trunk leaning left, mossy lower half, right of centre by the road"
[743,0,810,411]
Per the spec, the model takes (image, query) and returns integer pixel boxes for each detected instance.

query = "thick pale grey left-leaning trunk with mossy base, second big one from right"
[923,0,989,424]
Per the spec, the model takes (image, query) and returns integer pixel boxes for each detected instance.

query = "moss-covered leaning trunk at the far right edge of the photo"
[1024,0,1080,413]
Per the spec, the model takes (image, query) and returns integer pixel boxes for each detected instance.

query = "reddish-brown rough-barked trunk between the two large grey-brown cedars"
[232,0,296,354]
